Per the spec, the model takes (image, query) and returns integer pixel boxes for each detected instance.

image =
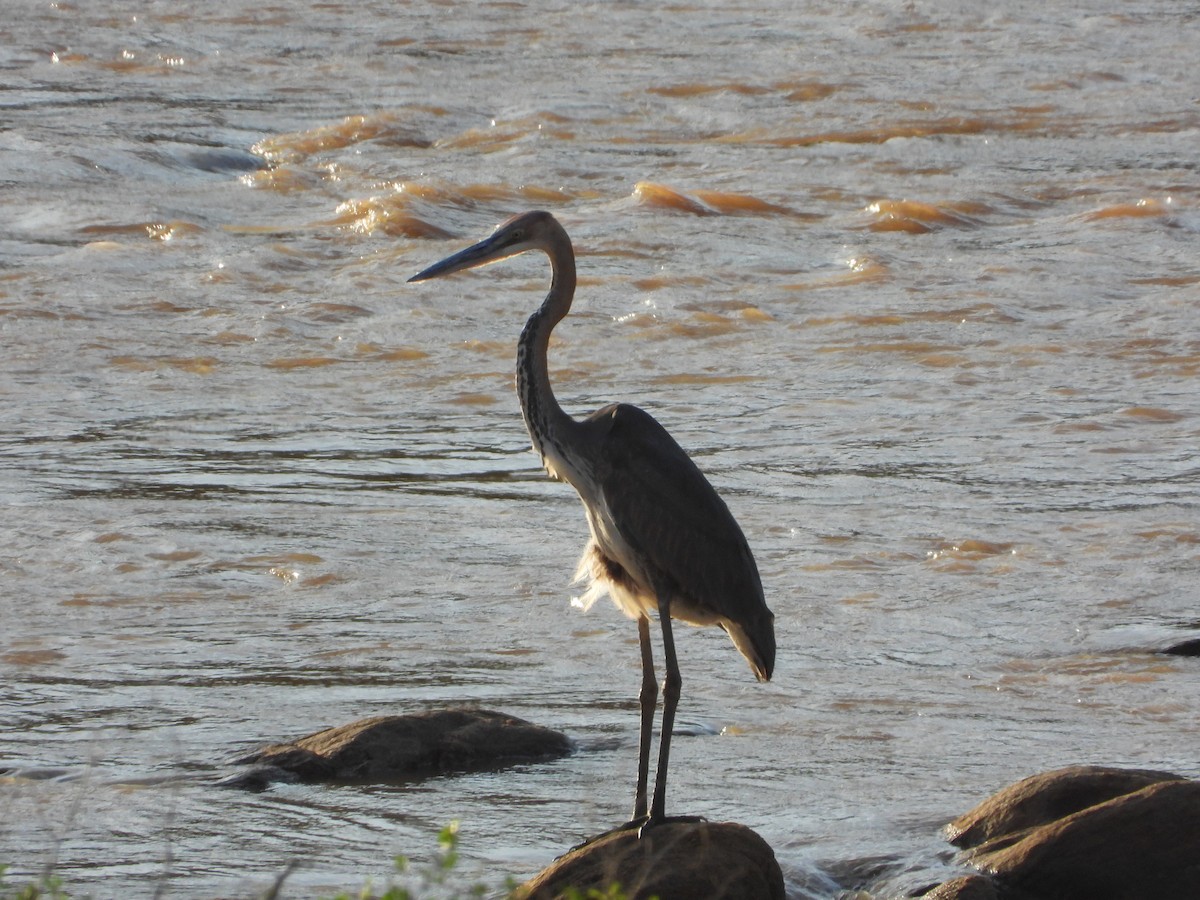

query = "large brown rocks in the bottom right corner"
[924,766,1200,900]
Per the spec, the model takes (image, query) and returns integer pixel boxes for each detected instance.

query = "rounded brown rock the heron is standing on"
[512,821,784,900]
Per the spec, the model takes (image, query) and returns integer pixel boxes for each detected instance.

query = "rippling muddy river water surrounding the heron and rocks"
[0,0,1200,898]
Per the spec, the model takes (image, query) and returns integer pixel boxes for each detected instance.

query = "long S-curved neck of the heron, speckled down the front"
[517,229,578,480]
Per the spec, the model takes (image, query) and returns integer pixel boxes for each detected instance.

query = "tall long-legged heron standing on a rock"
[409,210,775,828]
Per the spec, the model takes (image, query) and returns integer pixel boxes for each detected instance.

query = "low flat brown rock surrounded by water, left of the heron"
[232,709,572,790]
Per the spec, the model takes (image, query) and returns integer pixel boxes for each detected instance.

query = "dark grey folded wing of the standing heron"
[590,404,770,623]
